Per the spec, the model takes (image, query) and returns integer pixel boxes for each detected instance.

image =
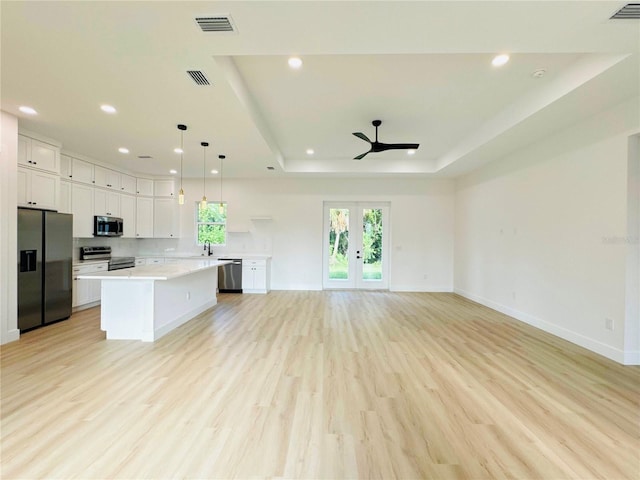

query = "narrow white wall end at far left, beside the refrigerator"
[0,112,20,344]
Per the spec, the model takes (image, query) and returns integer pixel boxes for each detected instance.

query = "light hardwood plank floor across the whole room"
[0,292,640,479]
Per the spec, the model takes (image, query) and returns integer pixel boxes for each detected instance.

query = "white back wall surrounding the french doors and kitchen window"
[175,178,454,291]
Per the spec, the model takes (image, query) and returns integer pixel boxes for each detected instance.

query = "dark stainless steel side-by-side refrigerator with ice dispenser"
[18,208,73,331]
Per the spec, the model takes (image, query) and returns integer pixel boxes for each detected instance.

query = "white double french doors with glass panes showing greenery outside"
[323,202,389,289]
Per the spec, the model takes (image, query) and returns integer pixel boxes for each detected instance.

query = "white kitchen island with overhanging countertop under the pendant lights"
[78,259,229,342]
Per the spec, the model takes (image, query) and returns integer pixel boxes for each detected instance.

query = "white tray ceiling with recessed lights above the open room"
[0,0,640,177]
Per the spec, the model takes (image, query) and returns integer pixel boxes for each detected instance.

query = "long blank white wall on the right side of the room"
[454,99,640,363]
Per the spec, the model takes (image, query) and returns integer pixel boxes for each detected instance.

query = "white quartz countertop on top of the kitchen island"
[77,259,230,280]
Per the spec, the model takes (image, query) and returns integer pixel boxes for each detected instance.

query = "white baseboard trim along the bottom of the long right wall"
[453,288,640,365]
